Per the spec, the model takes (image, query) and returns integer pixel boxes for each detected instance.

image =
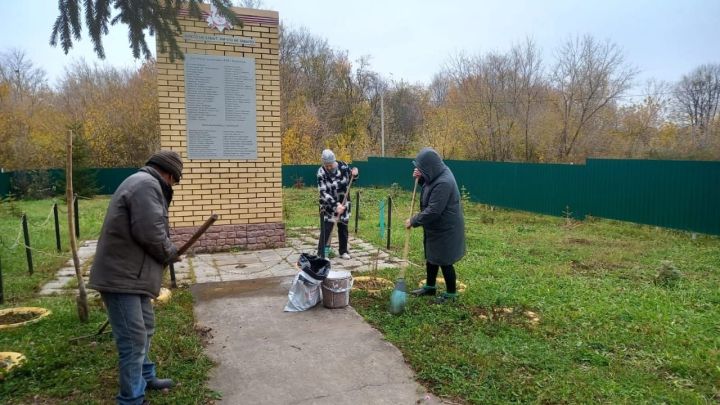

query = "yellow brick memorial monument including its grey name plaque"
[157,4,285,251]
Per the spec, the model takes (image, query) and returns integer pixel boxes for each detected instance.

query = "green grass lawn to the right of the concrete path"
[285,188,720,404]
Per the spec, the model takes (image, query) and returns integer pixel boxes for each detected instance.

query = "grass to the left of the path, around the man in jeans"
[0,198,218,404]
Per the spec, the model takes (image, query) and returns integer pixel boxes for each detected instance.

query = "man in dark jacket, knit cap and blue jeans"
[88,150,183,404]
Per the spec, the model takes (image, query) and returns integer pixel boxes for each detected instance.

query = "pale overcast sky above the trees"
[0,0,720,90]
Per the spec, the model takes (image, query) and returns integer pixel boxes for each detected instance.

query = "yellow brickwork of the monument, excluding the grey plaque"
[157,5,284,250]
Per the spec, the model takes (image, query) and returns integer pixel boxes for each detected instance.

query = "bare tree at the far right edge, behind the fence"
[674,64,720,147]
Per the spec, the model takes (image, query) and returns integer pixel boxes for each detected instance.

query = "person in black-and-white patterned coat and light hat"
[317,149,359,260]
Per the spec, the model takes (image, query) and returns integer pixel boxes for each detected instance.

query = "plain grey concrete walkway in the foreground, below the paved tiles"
[192,277,439,405]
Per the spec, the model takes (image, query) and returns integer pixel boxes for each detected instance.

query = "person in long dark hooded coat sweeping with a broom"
[405,148,465,303]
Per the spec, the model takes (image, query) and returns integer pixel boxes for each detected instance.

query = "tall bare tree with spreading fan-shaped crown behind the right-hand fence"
[552,36,637,160]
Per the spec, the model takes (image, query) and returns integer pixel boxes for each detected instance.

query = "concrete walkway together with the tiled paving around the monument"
[41,228,440,405]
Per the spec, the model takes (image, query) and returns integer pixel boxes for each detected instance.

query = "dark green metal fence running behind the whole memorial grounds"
[0,158,720,235]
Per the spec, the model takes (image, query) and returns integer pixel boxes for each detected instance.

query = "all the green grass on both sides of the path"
[0,188,720,404]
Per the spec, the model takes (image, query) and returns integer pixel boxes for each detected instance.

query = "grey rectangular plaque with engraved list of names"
[185,54,257,159]
